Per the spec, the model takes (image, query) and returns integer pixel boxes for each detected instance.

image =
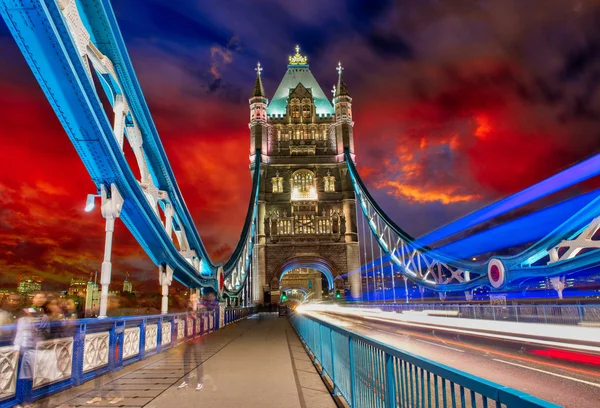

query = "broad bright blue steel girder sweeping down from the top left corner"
[0,0,216,288]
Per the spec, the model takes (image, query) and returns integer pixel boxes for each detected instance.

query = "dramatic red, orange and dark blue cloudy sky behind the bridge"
[0,0,600,294]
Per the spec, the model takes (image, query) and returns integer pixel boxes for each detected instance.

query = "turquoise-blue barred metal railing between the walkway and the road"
[290,313,558,408]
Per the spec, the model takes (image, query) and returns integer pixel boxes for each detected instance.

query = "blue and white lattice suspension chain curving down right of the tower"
[345,151,600,292]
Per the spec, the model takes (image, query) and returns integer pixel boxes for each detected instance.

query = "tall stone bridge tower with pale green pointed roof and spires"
[249,47,361,303]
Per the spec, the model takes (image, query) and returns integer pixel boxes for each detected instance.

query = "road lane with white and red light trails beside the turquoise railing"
[309,311,600,408]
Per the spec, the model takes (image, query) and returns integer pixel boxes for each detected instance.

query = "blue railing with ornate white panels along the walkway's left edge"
[0,308,252,408]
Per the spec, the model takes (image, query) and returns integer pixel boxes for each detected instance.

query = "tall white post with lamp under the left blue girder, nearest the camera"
[98,184,123,318]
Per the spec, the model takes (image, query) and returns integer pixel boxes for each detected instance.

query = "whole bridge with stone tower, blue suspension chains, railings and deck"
[0,0,600,407]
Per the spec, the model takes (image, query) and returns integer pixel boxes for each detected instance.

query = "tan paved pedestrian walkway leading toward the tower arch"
[43,314,335,408]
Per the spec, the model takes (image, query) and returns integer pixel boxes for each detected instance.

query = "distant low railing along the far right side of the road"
[351,303,600,326]
